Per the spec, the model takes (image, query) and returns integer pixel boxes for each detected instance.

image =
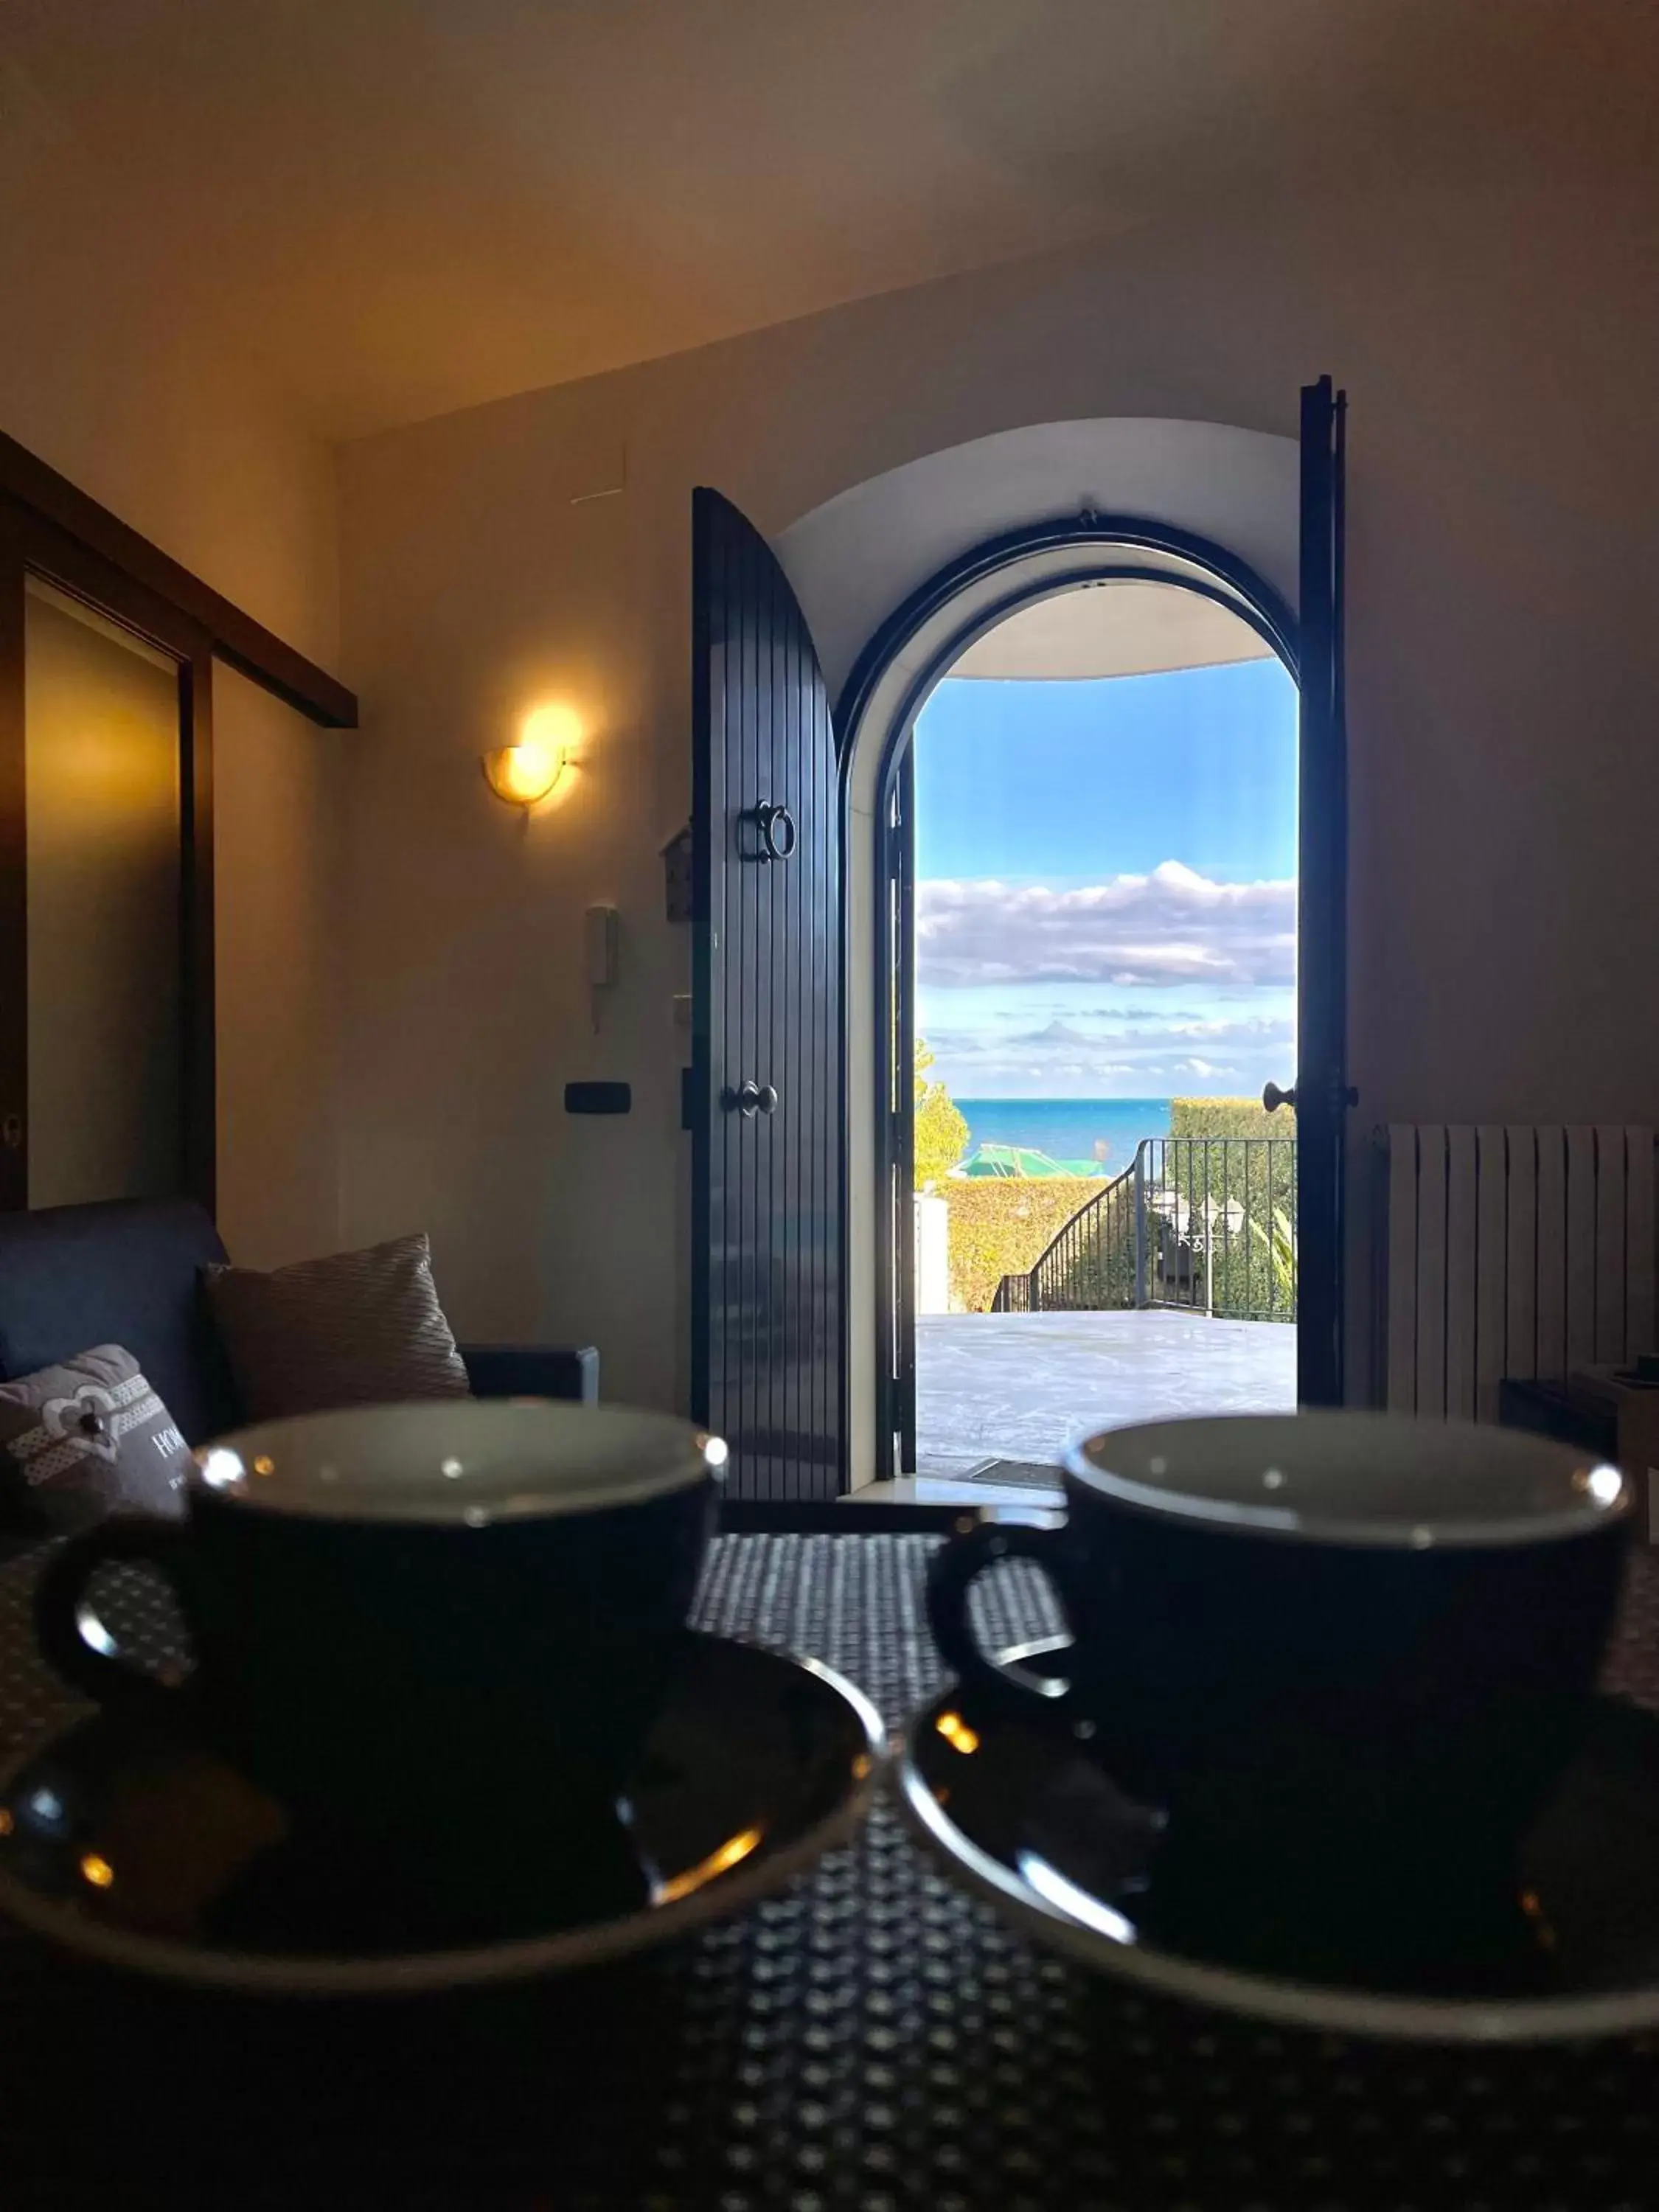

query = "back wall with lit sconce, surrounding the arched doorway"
[343,179,1659,1402]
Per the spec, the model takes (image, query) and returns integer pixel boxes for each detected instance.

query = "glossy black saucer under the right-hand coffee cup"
[898,1639,1659,2042]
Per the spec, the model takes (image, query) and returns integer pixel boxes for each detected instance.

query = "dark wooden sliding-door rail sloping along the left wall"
[0,431,356,730]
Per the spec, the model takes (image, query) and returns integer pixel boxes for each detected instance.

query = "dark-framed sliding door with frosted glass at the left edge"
[0,535,217,1210]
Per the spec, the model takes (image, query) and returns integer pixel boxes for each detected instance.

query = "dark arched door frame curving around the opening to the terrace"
[836,513,1318,1480]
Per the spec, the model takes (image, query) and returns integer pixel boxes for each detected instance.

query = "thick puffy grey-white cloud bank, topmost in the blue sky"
[916,860,1296,989]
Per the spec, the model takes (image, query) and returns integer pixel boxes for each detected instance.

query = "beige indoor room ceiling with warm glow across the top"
[0,0,1659,434]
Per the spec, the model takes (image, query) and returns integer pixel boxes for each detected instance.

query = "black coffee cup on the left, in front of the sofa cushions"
[35,1400,726,1863]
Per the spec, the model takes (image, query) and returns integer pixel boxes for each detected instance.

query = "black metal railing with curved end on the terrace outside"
[991,1137,1296,1321]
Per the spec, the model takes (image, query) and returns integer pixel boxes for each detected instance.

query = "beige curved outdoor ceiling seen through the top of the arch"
[951,584,1272,679]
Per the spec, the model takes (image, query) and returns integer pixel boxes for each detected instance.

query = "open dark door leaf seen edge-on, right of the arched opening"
[1294,376,1352,1405]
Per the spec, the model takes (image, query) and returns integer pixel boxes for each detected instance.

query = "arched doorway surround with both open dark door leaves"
[688,378,1345,1504]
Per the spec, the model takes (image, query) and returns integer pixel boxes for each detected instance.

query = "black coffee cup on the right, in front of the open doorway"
[927,1413,1630,1911]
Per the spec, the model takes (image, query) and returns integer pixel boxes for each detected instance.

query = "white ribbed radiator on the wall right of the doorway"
[1378,1124,1659,1420]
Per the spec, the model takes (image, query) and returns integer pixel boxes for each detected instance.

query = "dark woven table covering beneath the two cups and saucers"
[0,1535,1659,2212]
